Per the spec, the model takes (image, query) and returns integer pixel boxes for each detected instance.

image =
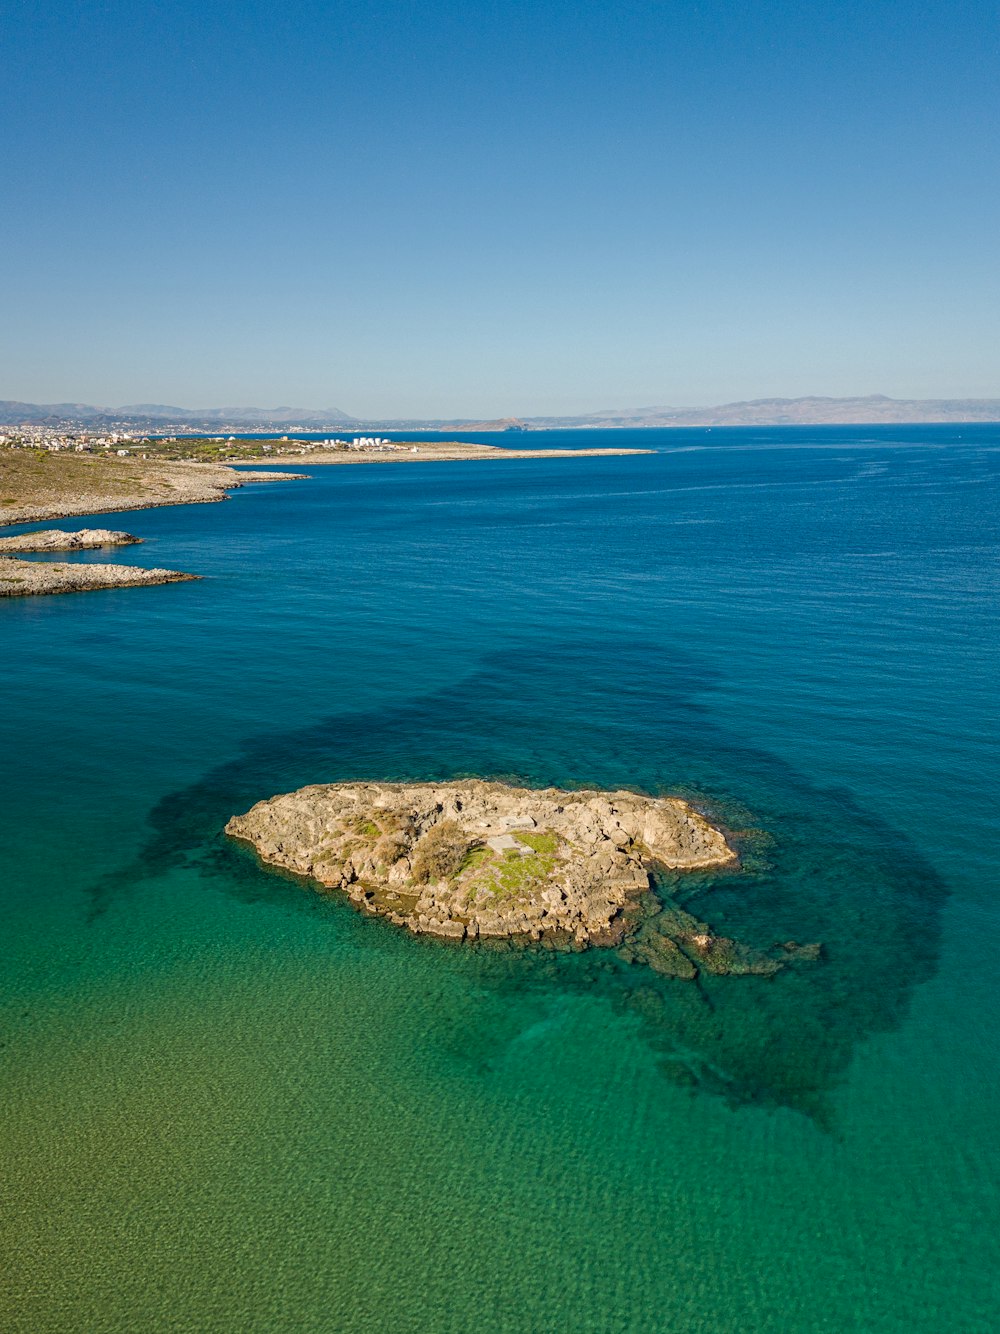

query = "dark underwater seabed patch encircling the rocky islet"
[92,642,947,1126]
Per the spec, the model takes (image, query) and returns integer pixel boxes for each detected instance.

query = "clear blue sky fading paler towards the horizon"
[0,0,1000,416]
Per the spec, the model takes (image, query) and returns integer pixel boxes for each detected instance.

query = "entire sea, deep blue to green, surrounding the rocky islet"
[0,427,1000,1334]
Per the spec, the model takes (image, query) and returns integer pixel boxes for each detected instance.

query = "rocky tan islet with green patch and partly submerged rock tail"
[225,780,817,978]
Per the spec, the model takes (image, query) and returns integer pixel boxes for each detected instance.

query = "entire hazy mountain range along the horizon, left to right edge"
[0,394,1000,432]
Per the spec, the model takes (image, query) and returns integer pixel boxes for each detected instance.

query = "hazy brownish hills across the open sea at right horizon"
[528,394,1000,428]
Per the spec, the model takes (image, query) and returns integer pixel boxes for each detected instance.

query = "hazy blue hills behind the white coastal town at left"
[0,399,355,430]
